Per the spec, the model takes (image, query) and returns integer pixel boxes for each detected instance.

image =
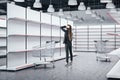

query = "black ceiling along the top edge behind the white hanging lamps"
[0,0,120,12]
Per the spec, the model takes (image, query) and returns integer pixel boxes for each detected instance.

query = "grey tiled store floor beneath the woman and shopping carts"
[0,52,118,80]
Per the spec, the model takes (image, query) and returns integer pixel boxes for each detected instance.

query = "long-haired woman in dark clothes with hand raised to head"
[61,24,73,64]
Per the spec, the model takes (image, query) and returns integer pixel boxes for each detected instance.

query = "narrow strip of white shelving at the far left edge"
[0,16,7,57]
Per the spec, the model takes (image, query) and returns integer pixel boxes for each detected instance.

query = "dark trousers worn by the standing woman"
[65,43,73,63]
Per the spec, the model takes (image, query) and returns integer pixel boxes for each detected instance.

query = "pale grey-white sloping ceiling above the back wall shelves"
[53,9,118,25]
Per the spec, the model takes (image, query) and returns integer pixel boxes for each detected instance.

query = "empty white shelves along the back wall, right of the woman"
[74,24,120,51]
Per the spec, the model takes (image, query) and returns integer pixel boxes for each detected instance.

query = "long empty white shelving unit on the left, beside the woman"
[0,3,73,70]
